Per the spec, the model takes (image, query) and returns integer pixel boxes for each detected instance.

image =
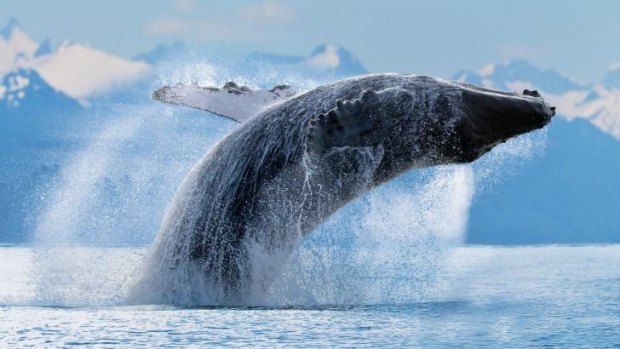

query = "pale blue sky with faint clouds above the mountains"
[0,0,620,83]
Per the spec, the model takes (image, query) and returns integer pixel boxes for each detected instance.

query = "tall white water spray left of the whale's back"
[33,105,230,306]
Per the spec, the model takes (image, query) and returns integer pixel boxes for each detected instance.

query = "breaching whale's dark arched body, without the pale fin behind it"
[138,74,555,304]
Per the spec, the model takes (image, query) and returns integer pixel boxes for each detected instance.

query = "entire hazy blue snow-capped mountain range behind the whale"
[0,20,620,244]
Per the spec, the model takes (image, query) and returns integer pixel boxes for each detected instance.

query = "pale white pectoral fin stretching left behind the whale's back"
[153,81,297,122]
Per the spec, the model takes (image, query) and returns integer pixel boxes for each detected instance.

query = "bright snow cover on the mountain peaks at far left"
[0,18,149,106]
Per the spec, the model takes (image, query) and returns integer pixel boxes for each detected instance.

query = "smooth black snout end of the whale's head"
[446,83,555,162]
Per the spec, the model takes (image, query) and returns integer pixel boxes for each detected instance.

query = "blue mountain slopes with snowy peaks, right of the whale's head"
[453,60,620,244]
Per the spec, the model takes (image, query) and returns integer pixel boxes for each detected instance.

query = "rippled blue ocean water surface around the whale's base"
[0,245,620,348]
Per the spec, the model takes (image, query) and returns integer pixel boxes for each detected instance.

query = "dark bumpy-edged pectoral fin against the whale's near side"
[308,91,383,153]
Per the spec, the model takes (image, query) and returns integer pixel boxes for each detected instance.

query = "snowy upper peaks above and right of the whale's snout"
[454,60,620,139]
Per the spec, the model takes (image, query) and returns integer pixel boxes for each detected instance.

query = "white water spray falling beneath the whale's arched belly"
[267,166,474,305]
